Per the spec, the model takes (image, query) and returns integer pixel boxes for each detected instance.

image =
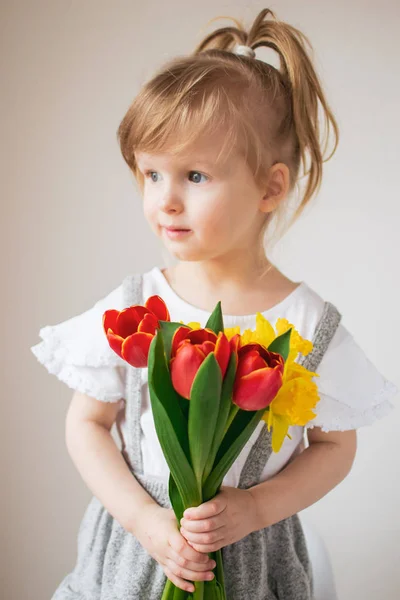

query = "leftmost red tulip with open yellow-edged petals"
[103,295,171,367]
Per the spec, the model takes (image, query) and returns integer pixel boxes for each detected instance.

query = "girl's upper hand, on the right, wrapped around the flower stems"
[181,486,259,553]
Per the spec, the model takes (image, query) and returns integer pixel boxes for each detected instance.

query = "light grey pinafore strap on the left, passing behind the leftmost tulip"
[122,273,144,473]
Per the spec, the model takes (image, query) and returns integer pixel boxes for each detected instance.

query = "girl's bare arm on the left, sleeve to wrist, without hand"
[65,392,157,532]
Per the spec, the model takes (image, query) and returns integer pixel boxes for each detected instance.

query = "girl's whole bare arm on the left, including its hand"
[66,392,214,591]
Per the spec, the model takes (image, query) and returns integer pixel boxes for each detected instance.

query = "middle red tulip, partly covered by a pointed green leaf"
[170,326,231,400]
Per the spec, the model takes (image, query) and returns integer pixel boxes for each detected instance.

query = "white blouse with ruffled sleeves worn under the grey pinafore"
[31,266,399,486]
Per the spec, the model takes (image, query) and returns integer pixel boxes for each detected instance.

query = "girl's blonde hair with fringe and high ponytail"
[118,8,339,255]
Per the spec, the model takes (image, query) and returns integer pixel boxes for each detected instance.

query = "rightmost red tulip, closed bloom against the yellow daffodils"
[231,340,285,410]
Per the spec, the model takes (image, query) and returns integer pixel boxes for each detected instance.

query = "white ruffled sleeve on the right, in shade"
[305,323,399,432]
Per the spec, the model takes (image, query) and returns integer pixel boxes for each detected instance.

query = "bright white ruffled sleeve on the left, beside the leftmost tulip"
[31,285,126,402]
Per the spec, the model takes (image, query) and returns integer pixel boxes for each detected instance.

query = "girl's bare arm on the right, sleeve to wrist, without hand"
[248,427,357,529]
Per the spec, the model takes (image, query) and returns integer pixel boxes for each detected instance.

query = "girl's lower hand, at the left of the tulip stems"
[131,504,215,592]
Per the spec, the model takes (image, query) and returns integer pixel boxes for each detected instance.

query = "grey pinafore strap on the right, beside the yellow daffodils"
[238,302,342,489]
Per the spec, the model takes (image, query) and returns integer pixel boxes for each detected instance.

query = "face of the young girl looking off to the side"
[135,139,266,261]
